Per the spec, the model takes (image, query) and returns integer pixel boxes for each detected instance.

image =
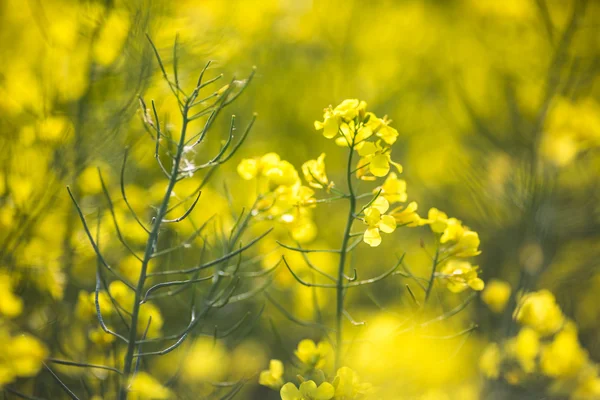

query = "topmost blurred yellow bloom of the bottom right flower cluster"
[513,289,565,336]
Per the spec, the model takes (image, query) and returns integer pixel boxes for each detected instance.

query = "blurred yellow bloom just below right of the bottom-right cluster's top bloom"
[540,322,588,379]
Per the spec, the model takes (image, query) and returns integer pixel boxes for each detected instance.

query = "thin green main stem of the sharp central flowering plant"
[335,139,356,371]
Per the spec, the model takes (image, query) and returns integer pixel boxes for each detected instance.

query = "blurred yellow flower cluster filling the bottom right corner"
[480,290,600,399]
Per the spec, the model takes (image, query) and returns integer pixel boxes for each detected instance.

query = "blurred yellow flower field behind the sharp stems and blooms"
[0,0,600,399]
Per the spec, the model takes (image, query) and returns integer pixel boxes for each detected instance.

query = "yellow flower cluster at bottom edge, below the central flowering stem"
[259,339,373,400]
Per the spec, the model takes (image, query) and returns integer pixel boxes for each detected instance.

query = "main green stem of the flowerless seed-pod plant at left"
[119,102,189,400]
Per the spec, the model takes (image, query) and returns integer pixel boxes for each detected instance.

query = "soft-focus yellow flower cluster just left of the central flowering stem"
[237,153,318,243]
